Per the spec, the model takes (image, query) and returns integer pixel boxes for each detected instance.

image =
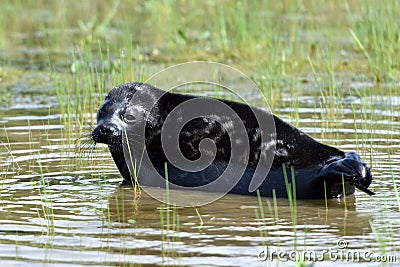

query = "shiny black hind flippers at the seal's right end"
[320,152,375,196]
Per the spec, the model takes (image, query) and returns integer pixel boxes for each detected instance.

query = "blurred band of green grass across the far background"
[0,0,399,76]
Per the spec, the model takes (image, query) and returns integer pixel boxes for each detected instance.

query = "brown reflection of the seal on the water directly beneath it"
[109,186,373,241]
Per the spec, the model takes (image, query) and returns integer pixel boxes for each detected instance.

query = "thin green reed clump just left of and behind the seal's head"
[52,36,150,173]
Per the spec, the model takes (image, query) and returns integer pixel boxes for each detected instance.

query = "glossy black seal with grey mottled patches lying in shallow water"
[92,82,374,198]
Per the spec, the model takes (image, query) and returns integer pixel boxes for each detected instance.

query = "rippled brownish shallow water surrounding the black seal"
[0,70,400,266]
